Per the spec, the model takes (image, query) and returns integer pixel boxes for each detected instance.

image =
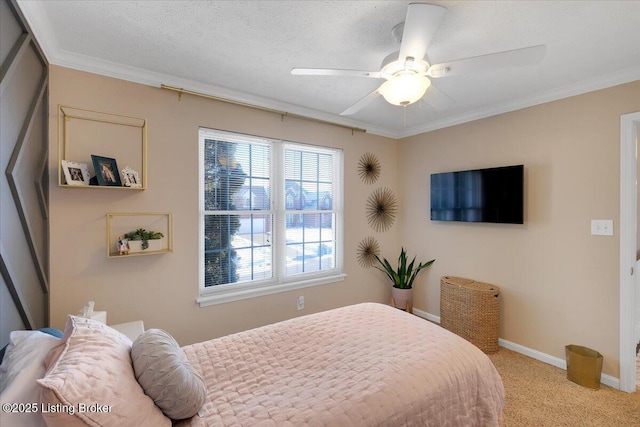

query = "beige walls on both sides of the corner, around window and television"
[50,66,640,377]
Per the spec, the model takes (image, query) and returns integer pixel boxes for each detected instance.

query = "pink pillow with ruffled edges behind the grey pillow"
[37,316,171,427]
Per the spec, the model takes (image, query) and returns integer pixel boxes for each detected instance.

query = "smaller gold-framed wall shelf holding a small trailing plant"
[107,212,173,258]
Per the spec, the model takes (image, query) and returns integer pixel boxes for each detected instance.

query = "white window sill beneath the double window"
[196,273,347,307]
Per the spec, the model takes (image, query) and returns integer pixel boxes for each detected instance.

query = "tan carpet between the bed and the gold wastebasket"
[489,348,640,427]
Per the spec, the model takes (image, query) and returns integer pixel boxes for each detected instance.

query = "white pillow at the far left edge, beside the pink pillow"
[0,331,60,427]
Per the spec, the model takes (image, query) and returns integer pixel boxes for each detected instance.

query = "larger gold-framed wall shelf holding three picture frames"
[58,105,147,191]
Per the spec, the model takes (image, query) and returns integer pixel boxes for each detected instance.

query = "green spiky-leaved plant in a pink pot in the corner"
[374,247,435,311]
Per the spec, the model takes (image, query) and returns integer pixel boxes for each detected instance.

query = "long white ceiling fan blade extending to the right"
[427,45,547,78]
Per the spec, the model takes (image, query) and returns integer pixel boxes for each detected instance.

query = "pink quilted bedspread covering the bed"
[181,303,504,427]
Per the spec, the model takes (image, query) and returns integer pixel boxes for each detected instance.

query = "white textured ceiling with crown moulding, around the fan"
[18,0,640,138]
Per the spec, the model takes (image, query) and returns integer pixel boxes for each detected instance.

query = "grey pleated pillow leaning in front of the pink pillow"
[131,329,207,420]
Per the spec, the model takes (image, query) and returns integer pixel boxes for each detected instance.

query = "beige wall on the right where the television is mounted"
[398,81,640,377]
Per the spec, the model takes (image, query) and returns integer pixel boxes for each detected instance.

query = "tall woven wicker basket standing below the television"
[440,276,500,353]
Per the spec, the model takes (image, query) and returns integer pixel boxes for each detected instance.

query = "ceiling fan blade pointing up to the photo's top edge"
[399,3,447,62]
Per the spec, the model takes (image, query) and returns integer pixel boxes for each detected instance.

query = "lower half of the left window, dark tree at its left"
[205,214,273,286]
